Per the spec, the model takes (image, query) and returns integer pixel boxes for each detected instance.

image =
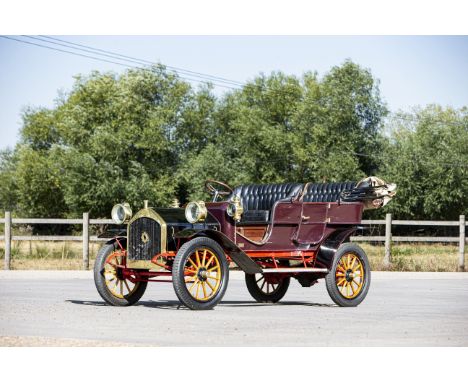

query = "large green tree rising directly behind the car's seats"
[179,61,387,197]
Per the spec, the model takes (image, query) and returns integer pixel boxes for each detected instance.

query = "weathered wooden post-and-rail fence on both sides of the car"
[0,211,466,272]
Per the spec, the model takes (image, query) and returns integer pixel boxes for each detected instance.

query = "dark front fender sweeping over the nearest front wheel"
[174,228,262,275]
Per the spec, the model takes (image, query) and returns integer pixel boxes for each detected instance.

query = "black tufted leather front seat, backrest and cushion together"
[229,183,303,223]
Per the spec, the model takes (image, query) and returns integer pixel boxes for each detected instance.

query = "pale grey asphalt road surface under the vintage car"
[0,271,468,346]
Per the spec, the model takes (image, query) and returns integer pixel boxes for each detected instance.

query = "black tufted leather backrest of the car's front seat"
[229,183,303,211]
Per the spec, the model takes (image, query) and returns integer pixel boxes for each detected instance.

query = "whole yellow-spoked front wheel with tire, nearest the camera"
[172,237,229,310]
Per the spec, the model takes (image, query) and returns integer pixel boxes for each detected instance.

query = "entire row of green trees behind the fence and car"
[0,61,468,218]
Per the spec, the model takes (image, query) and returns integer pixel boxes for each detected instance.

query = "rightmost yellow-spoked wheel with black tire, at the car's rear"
[326,243,370,306]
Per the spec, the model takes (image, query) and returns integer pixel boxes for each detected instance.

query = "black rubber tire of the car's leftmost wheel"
[94,243,148,306]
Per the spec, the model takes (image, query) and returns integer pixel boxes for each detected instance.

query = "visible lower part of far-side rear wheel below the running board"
[245,273,291,303]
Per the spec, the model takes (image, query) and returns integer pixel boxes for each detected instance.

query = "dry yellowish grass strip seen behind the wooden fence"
[0,241,462,272]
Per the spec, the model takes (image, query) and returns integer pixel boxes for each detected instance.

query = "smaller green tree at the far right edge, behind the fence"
[382,105,468,220]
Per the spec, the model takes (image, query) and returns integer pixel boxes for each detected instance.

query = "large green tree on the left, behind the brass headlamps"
[2,67,203,217]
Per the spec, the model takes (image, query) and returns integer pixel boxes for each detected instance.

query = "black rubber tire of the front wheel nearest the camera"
[172,237,229,310]
